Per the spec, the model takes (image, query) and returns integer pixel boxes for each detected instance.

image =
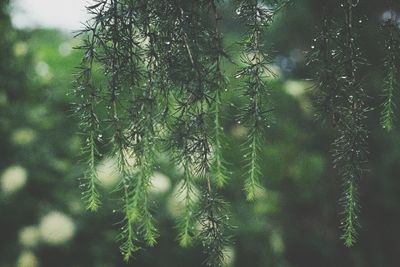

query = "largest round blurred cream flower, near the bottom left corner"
[39,211,75,245]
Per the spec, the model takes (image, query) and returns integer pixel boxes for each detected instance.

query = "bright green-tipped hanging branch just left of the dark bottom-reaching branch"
[162,1,202,247]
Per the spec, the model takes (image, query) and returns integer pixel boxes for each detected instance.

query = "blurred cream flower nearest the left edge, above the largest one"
[1,166,27,194]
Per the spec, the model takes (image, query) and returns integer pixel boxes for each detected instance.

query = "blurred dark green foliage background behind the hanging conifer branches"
[0,0,400,267]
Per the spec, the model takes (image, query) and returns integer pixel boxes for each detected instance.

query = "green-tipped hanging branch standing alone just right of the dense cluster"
[236,0,289,200]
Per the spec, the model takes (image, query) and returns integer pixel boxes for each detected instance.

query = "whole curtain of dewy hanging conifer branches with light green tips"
[76,0,398,266]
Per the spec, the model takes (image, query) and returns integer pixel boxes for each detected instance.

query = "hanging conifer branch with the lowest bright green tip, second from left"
[104,0,143,261]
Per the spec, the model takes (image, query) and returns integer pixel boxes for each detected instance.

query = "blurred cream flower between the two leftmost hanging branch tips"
[96,158,121,188]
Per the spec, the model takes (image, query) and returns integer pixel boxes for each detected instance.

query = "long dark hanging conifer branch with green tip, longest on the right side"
[334,0,368,247]
